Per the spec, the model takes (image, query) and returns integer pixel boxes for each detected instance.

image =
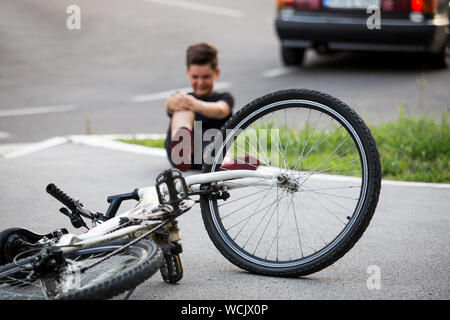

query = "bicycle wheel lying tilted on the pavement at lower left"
[0,240,163,300]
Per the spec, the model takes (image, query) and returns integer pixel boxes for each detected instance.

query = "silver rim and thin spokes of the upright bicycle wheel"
[209,99,368,268]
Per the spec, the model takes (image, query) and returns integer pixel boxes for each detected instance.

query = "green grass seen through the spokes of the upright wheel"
[233,125,361,176]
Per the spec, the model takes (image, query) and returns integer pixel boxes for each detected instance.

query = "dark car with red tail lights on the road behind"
[275,0,450,67]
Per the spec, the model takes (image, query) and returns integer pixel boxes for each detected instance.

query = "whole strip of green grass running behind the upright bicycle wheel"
[121,109,450,183]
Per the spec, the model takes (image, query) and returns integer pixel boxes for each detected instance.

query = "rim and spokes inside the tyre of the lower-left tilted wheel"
[0,246,147,300]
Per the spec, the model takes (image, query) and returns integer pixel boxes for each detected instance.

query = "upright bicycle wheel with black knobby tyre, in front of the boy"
[201,89,381,276]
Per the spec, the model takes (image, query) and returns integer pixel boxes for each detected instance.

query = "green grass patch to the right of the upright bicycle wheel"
[370,109,450,183]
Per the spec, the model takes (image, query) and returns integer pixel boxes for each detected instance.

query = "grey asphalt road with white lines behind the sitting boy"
[0,0,450,144]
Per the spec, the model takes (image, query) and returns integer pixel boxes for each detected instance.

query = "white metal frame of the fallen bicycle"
[55,169,276,252]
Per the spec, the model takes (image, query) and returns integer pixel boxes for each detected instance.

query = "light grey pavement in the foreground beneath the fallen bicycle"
[0,144,450,300]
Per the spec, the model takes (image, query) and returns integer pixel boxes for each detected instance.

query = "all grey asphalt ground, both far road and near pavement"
[0,0,450,299]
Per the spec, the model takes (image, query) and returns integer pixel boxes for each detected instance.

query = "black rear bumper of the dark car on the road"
[276,14,449,52]
